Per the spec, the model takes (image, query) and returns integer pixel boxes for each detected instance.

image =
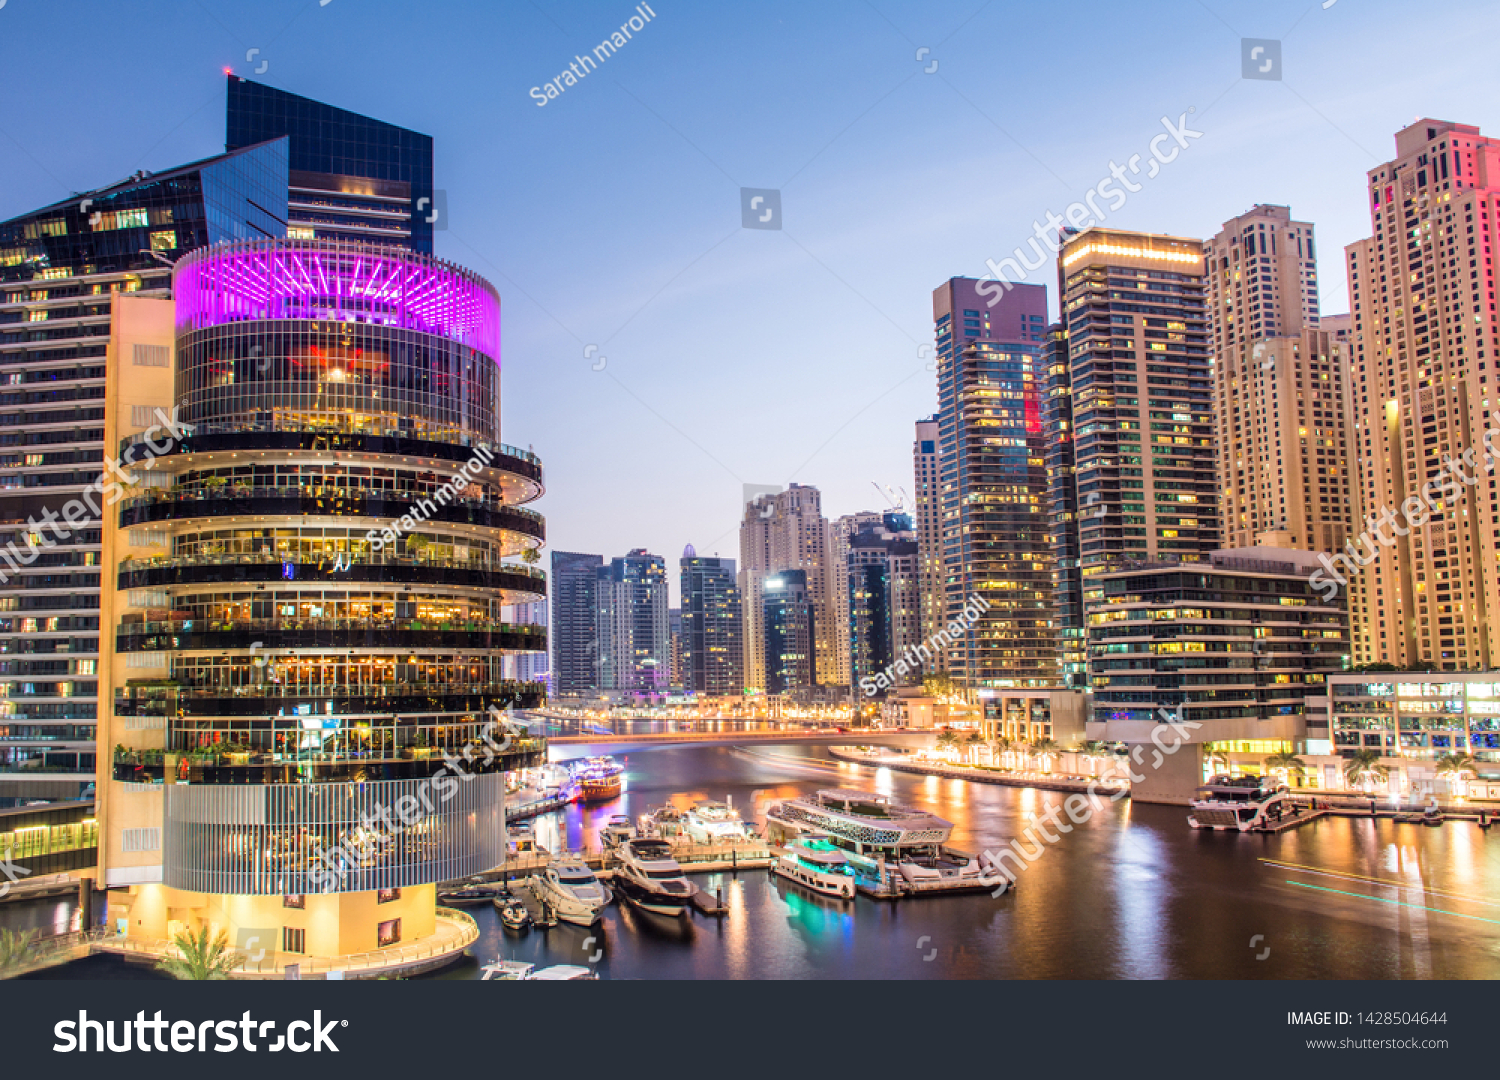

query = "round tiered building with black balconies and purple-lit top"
[98,240,546,971]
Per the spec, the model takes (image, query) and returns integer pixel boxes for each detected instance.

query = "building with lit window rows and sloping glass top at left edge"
[0,140,287,807]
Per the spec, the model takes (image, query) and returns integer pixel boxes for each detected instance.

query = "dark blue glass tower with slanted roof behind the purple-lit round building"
[225,75,440,255]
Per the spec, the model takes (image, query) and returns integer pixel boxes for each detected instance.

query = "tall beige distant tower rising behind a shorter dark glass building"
[740,483,845,689]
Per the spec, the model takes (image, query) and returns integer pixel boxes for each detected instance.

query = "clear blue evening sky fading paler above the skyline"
[0,0,1500,591]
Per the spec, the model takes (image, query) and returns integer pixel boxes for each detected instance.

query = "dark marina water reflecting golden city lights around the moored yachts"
[11,747,1500,980]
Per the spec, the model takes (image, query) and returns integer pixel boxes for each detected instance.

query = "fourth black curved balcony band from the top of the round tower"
[116,618,548,653]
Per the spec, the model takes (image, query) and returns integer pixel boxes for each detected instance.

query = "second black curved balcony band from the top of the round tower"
[120,485,546,542]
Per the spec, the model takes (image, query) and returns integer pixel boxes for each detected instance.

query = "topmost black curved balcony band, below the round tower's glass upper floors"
[120,423,545,503]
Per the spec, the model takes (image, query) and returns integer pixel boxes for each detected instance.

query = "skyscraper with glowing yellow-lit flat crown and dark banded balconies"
[1059,228,1218,582]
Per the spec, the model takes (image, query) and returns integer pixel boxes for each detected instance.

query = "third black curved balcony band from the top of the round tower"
[119,552,548,605]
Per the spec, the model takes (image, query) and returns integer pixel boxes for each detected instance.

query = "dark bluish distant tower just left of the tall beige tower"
[678,545,744,698]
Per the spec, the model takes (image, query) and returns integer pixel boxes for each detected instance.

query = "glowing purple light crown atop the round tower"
[173,240,500,363]
